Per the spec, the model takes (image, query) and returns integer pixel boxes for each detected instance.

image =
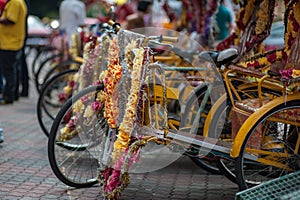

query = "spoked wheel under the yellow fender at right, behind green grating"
[236,98,300,190]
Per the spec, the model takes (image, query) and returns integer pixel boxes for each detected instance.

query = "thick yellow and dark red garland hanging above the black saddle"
[216,0,275,58]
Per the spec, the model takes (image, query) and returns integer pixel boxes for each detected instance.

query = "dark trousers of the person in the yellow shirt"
[0,50,22,102]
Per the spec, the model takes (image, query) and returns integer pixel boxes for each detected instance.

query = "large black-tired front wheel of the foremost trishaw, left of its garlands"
[48,85,107,188]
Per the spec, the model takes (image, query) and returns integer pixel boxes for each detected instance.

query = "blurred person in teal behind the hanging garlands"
[216,0,232,41]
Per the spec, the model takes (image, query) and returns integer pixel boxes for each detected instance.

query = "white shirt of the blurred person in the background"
[59,0,86,44]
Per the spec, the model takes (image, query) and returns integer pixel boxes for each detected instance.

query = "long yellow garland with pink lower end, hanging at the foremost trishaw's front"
[98,42,144,199]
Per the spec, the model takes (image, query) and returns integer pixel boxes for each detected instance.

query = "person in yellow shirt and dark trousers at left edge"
[0,0,27,105]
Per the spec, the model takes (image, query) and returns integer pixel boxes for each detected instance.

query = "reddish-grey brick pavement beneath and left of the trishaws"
[0,80,238,200]
